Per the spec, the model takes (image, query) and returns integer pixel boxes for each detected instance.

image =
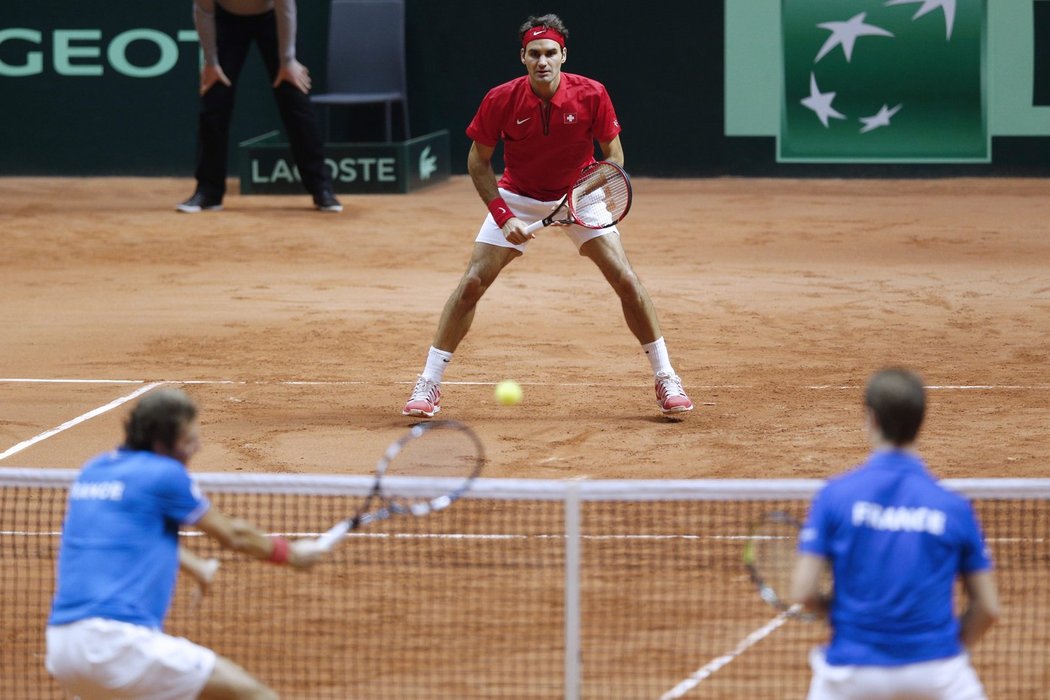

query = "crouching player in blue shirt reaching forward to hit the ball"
[46,388,321,700]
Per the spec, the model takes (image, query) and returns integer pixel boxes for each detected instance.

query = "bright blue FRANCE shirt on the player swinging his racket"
[48,449,209,630]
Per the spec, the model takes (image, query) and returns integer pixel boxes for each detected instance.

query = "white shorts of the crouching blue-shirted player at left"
[46,617,215,700]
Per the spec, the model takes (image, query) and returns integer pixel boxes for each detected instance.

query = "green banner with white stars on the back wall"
[777,0,990,163]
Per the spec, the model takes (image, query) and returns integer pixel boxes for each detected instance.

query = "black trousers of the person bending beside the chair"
[195,3,332,198]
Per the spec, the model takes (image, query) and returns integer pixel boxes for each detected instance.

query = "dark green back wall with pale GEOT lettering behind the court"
[0,0,1050,177]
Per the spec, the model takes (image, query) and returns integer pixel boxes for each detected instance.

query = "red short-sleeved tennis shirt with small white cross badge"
[466,72,621,201]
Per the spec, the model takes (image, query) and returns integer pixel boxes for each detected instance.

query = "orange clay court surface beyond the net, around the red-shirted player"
[0,176,1050,698]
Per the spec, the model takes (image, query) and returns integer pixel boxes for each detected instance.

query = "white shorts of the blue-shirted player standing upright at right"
[807,646,988,700]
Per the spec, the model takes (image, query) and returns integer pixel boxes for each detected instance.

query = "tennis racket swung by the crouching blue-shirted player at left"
[308,421,485,551]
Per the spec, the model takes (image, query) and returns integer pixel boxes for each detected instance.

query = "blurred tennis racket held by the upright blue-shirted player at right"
[743,511,831,619]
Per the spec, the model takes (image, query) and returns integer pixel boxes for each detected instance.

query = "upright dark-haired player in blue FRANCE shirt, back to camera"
[792,369,999,700]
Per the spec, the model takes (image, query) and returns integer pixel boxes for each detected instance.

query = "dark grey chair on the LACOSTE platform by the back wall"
[310,0,408,142]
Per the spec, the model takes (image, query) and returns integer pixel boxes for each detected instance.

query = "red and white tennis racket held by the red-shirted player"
[525,161,631,233]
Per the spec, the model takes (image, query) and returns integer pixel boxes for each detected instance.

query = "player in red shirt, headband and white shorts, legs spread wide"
[401,15,693,418]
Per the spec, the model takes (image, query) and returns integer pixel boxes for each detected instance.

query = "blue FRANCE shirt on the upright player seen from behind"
[799,450,991,666]
